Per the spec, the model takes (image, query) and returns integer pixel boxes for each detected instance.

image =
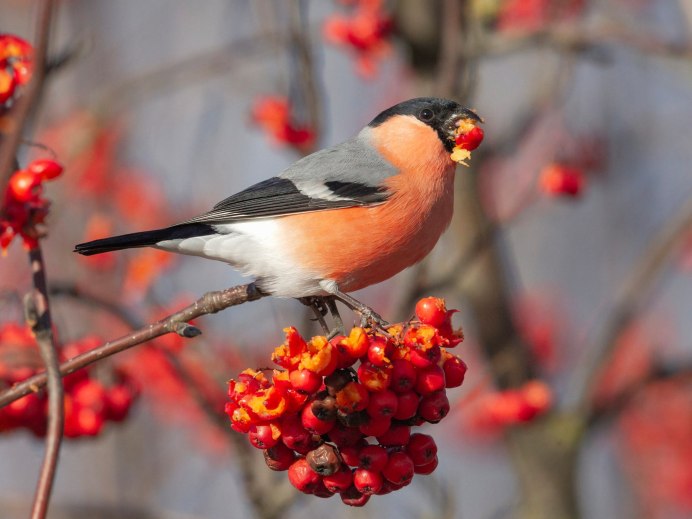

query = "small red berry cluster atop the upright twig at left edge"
[0,159,63,251]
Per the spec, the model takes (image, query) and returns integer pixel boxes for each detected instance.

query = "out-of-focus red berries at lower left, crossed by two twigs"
[0,323,138,438]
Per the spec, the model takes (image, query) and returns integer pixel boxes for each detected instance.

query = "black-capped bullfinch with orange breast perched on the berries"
[74,97,482,334]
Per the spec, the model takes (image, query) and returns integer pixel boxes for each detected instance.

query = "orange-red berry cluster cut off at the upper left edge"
[0,34,33,109]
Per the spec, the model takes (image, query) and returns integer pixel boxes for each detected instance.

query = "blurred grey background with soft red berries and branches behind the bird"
[0,0,692,519]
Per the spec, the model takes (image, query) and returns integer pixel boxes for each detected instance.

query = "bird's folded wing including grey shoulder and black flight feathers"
[183,136,398,224]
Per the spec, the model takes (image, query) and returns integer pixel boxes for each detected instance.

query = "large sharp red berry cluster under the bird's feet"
[226,298,467,506]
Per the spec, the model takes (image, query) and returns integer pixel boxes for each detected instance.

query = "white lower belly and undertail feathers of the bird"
[156,219,326,297]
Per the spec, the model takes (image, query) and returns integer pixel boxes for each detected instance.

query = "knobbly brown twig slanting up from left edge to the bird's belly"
[0,283,265,407]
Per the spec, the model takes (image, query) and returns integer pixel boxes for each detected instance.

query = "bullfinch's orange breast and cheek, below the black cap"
[281,116,455,291]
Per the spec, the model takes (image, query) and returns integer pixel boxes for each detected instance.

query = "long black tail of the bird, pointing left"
[74,223,215,256]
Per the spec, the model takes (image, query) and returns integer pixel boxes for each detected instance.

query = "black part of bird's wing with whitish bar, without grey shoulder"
[183,177,389,224]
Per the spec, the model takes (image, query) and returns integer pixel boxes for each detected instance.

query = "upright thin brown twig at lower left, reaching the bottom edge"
[25,245,65,519]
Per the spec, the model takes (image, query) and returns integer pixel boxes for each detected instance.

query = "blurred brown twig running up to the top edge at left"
[0,0,53,203]
